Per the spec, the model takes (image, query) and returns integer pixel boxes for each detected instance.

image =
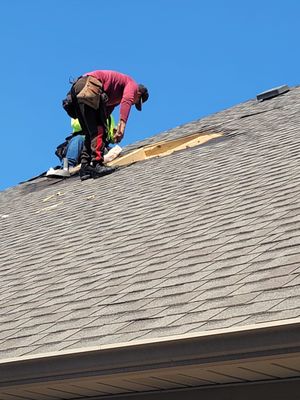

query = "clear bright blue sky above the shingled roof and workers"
[0,0,300,190]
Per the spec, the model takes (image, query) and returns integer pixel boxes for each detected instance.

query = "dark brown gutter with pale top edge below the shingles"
[0,318,300,389]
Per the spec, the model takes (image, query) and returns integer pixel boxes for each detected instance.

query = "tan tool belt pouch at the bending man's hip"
[74,75,108,110]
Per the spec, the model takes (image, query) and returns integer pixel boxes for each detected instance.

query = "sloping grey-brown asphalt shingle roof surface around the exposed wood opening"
[0,87,300,396]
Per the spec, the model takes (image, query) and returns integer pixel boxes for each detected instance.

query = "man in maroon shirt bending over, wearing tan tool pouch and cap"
[63,70,149,180]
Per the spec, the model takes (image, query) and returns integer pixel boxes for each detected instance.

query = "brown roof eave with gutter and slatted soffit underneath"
[0,318,300,399]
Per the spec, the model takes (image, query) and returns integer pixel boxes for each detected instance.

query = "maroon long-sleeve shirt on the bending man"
[85,70,138,122]
